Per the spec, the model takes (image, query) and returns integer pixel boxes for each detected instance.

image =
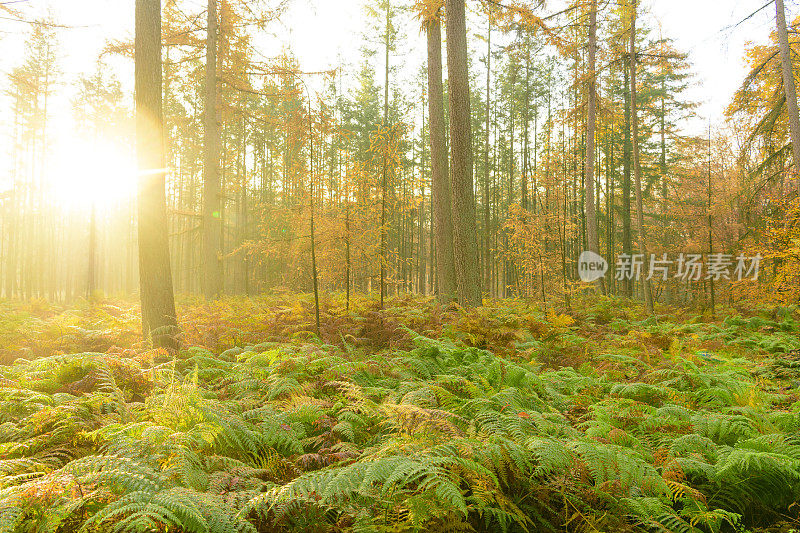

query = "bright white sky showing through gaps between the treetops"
[0,0,799,145]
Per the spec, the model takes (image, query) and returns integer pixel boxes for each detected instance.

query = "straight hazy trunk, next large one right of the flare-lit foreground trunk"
[203,0,223,300]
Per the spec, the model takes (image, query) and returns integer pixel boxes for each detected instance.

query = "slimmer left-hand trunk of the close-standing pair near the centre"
[427,14,456,302]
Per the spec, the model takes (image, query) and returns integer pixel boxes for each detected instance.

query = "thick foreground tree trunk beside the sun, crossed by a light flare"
[134,0,177,348]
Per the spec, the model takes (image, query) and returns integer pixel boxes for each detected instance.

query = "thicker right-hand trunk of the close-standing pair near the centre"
[445,0,481,307]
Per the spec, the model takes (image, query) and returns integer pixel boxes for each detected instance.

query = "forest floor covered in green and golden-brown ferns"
[0,295,800,533]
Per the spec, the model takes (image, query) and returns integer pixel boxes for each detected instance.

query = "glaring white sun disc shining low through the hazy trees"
[45,139,136,210]
